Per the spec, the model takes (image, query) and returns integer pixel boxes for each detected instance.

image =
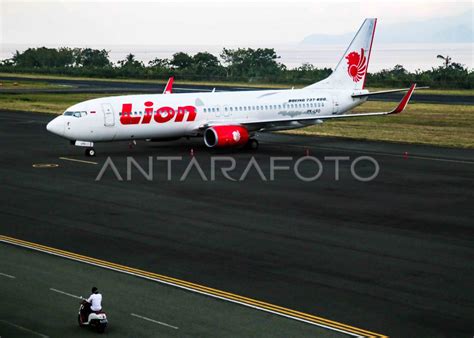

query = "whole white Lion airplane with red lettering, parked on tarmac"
[46,18,416,156]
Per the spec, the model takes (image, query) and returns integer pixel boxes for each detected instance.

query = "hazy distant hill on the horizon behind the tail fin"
[301,10,474,45]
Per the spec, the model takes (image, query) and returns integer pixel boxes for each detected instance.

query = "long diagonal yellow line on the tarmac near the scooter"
[0,235,387,338]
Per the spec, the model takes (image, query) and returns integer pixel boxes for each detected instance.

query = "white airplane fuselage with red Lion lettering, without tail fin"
[48,89,365,142]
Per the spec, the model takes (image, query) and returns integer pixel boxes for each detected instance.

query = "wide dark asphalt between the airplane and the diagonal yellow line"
[0,112,474,337]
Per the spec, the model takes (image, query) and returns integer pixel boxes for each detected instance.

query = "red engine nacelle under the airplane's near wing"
[204,126,249,148]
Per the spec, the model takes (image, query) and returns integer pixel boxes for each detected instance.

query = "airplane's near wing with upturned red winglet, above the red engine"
[194,84,416,131]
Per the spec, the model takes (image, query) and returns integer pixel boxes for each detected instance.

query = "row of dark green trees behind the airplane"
[0,47,474,89]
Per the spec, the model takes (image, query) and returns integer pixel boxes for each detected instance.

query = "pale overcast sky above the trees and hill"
[0,0,473,47]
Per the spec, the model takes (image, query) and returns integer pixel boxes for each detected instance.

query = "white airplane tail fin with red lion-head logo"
[306,19,377,90]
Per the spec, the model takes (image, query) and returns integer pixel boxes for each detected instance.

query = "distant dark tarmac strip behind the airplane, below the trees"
[0,76,474,105]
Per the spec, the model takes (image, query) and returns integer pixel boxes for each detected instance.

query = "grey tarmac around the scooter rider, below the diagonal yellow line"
[0,244,340,338]
